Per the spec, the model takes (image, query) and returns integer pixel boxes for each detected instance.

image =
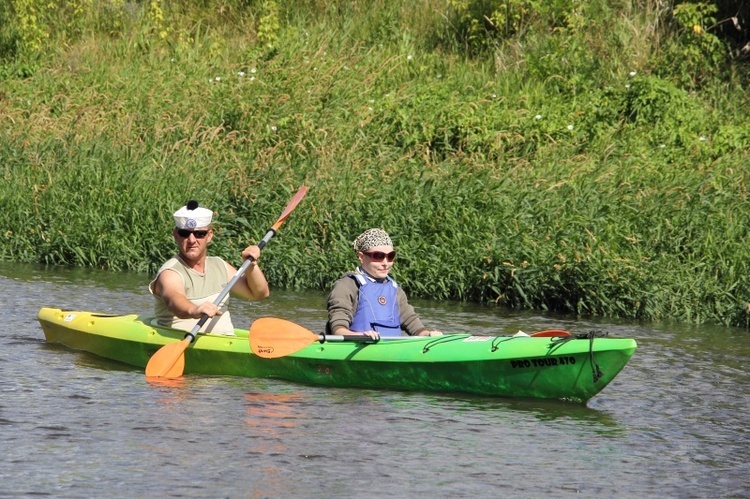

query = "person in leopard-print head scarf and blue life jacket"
[326,229,443,339]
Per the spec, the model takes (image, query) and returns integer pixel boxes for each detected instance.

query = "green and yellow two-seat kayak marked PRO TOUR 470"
[38,308,636,402]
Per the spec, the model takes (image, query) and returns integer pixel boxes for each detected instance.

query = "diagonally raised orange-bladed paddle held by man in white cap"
[146,186,307,378]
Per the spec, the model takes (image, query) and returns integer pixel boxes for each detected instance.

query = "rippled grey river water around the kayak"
[0,263,750,498]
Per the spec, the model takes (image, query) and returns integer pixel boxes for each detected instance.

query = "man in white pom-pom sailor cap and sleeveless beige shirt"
[148,201,270,335]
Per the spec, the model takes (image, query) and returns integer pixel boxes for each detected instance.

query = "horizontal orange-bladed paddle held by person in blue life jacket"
[249,317,570,359]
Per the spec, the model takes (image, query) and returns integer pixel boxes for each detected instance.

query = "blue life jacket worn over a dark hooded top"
[349,274,401,336]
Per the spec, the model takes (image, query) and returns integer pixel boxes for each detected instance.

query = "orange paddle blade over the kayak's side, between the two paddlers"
[249,317,320,359]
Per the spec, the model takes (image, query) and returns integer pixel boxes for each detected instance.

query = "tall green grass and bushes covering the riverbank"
[0,0,750,326]
